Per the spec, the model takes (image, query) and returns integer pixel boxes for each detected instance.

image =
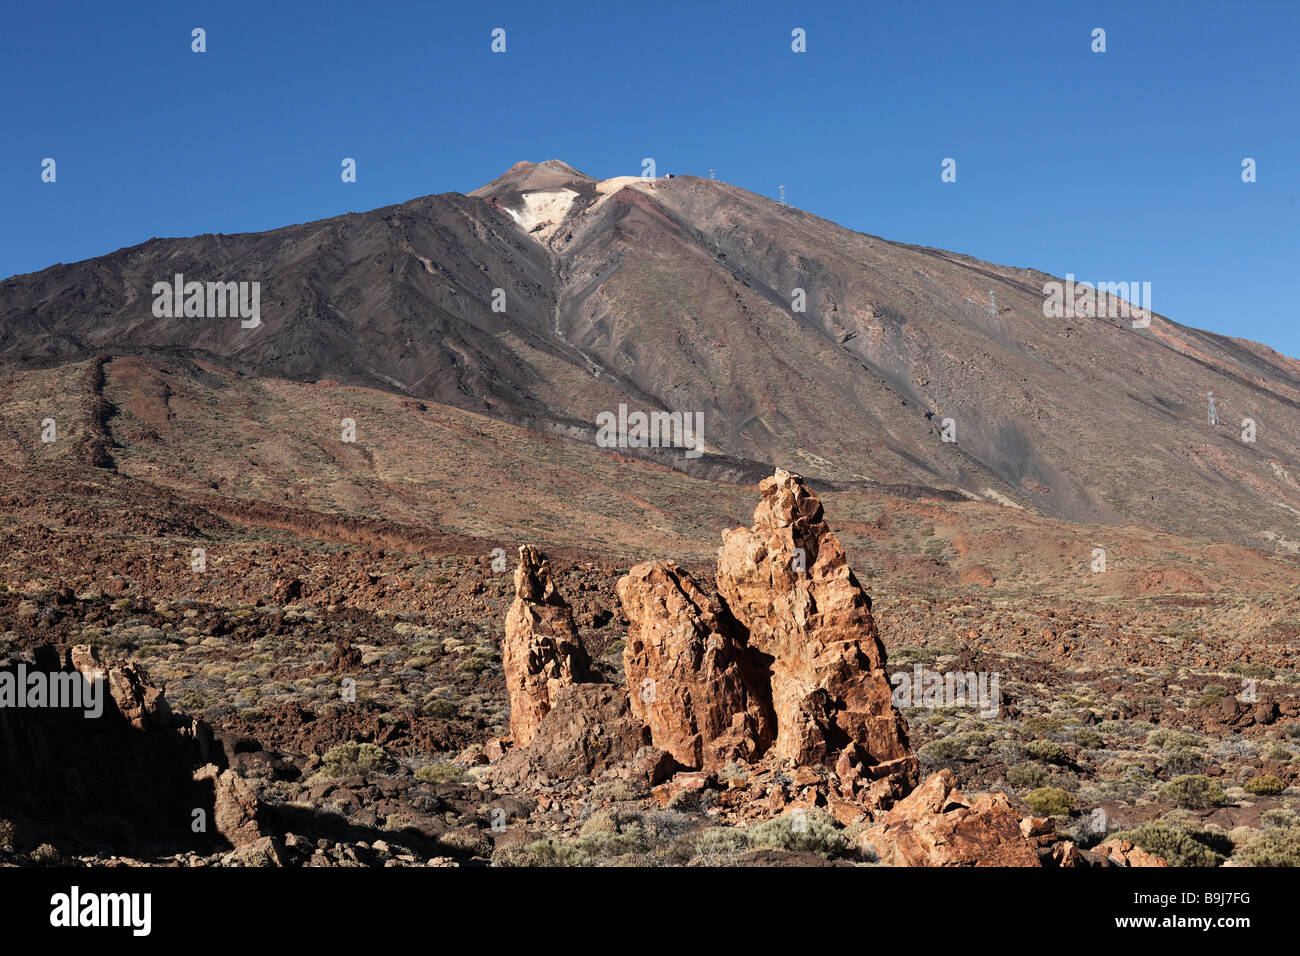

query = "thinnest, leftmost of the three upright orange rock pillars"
[502,545,593,747]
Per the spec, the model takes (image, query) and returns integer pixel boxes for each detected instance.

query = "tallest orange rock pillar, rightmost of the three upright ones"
[718,468,917,788]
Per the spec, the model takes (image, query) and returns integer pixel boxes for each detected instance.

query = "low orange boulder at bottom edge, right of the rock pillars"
[861,770,1041,866]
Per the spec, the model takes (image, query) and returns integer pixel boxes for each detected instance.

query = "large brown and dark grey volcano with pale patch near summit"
[0,160,1300,550]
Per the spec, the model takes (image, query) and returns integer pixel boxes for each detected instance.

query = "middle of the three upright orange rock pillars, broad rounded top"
[618,562,775,770]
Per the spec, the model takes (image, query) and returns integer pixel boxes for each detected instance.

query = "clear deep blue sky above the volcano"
[0,0,1300,355]
